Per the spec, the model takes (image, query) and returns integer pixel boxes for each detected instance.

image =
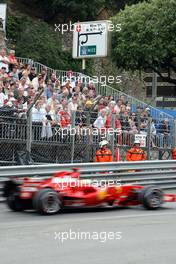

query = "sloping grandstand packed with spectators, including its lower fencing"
[0,51,175,164]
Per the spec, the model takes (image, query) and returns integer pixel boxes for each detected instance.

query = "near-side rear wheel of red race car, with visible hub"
[33,188,62,215]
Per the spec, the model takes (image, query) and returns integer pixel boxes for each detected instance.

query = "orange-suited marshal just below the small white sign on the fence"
[126,140,147,161]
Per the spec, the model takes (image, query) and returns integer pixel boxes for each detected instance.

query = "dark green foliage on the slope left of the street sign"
[7,15,80,71]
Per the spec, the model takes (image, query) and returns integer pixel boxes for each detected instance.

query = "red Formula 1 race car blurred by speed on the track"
[4,170,176,214]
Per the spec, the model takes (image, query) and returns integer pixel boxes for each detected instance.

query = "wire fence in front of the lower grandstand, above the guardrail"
[0,111,176,165]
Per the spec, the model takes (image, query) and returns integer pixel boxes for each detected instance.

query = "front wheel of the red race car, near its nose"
[139,186,164,210]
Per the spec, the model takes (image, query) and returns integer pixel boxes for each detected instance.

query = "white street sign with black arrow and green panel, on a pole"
[72,20,112,59]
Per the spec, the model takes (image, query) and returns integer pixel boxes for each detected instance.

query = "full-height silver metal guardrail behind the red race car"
[0,160,176,199]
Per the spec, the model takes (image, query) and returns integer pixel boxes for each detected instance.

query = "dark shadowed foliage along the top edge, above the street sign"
[21,0,144,22]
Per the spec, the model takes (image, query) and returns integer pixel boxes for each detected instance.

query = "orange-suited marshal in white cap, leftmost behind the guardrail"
[95,140,113,162]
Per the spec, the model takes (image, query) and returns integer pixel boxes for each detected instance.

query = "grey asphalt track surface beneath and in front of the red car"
[0,203,176,264]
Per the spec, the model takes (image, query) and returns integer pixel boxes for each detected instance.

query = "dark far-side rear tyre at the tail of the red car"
[7,189,24,212]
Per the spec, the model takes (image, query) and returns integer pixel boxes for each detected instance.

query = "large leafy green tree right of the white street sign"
[113,0,176,84]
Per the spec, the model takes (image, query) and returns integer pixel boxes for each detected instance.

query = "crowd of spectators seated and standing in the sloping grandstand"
[0,49,170,146]
